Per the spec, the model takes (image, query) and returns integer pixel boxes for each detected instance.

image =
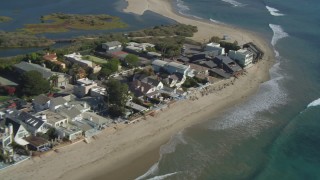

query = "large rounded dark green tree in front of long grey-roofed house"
[21,71,50,96]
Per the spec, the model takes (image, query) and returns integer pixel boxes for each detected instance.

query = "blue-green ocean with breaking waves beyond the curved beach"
[137,0,320,180]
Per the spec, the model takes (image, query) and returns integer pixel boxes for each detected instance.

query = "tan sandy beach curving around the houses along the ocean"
[0,0,274,180]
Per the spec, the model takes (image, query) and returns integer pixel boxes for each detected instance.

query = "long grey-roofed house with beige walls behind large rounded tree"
[14,61,70,87]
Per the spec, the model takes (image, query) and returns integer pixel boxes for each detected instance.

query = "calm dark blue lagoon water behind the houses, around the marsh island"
[0,0,174,57]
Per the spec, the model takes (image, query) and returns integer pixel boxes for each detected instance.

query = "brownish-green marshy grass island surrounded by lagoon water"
[23,13,127,34]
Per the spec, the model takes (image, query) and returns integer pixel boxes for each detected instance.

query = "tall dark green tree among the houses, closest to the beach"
[105,79,129,117]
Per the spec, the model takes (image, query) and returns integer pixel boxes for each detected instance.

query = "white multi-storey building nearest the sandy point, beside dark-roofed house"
[228,49,253,67]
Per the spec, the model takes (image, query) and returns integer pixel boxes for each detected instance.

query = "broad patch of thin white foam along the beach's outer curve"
[209,62,287,131]
